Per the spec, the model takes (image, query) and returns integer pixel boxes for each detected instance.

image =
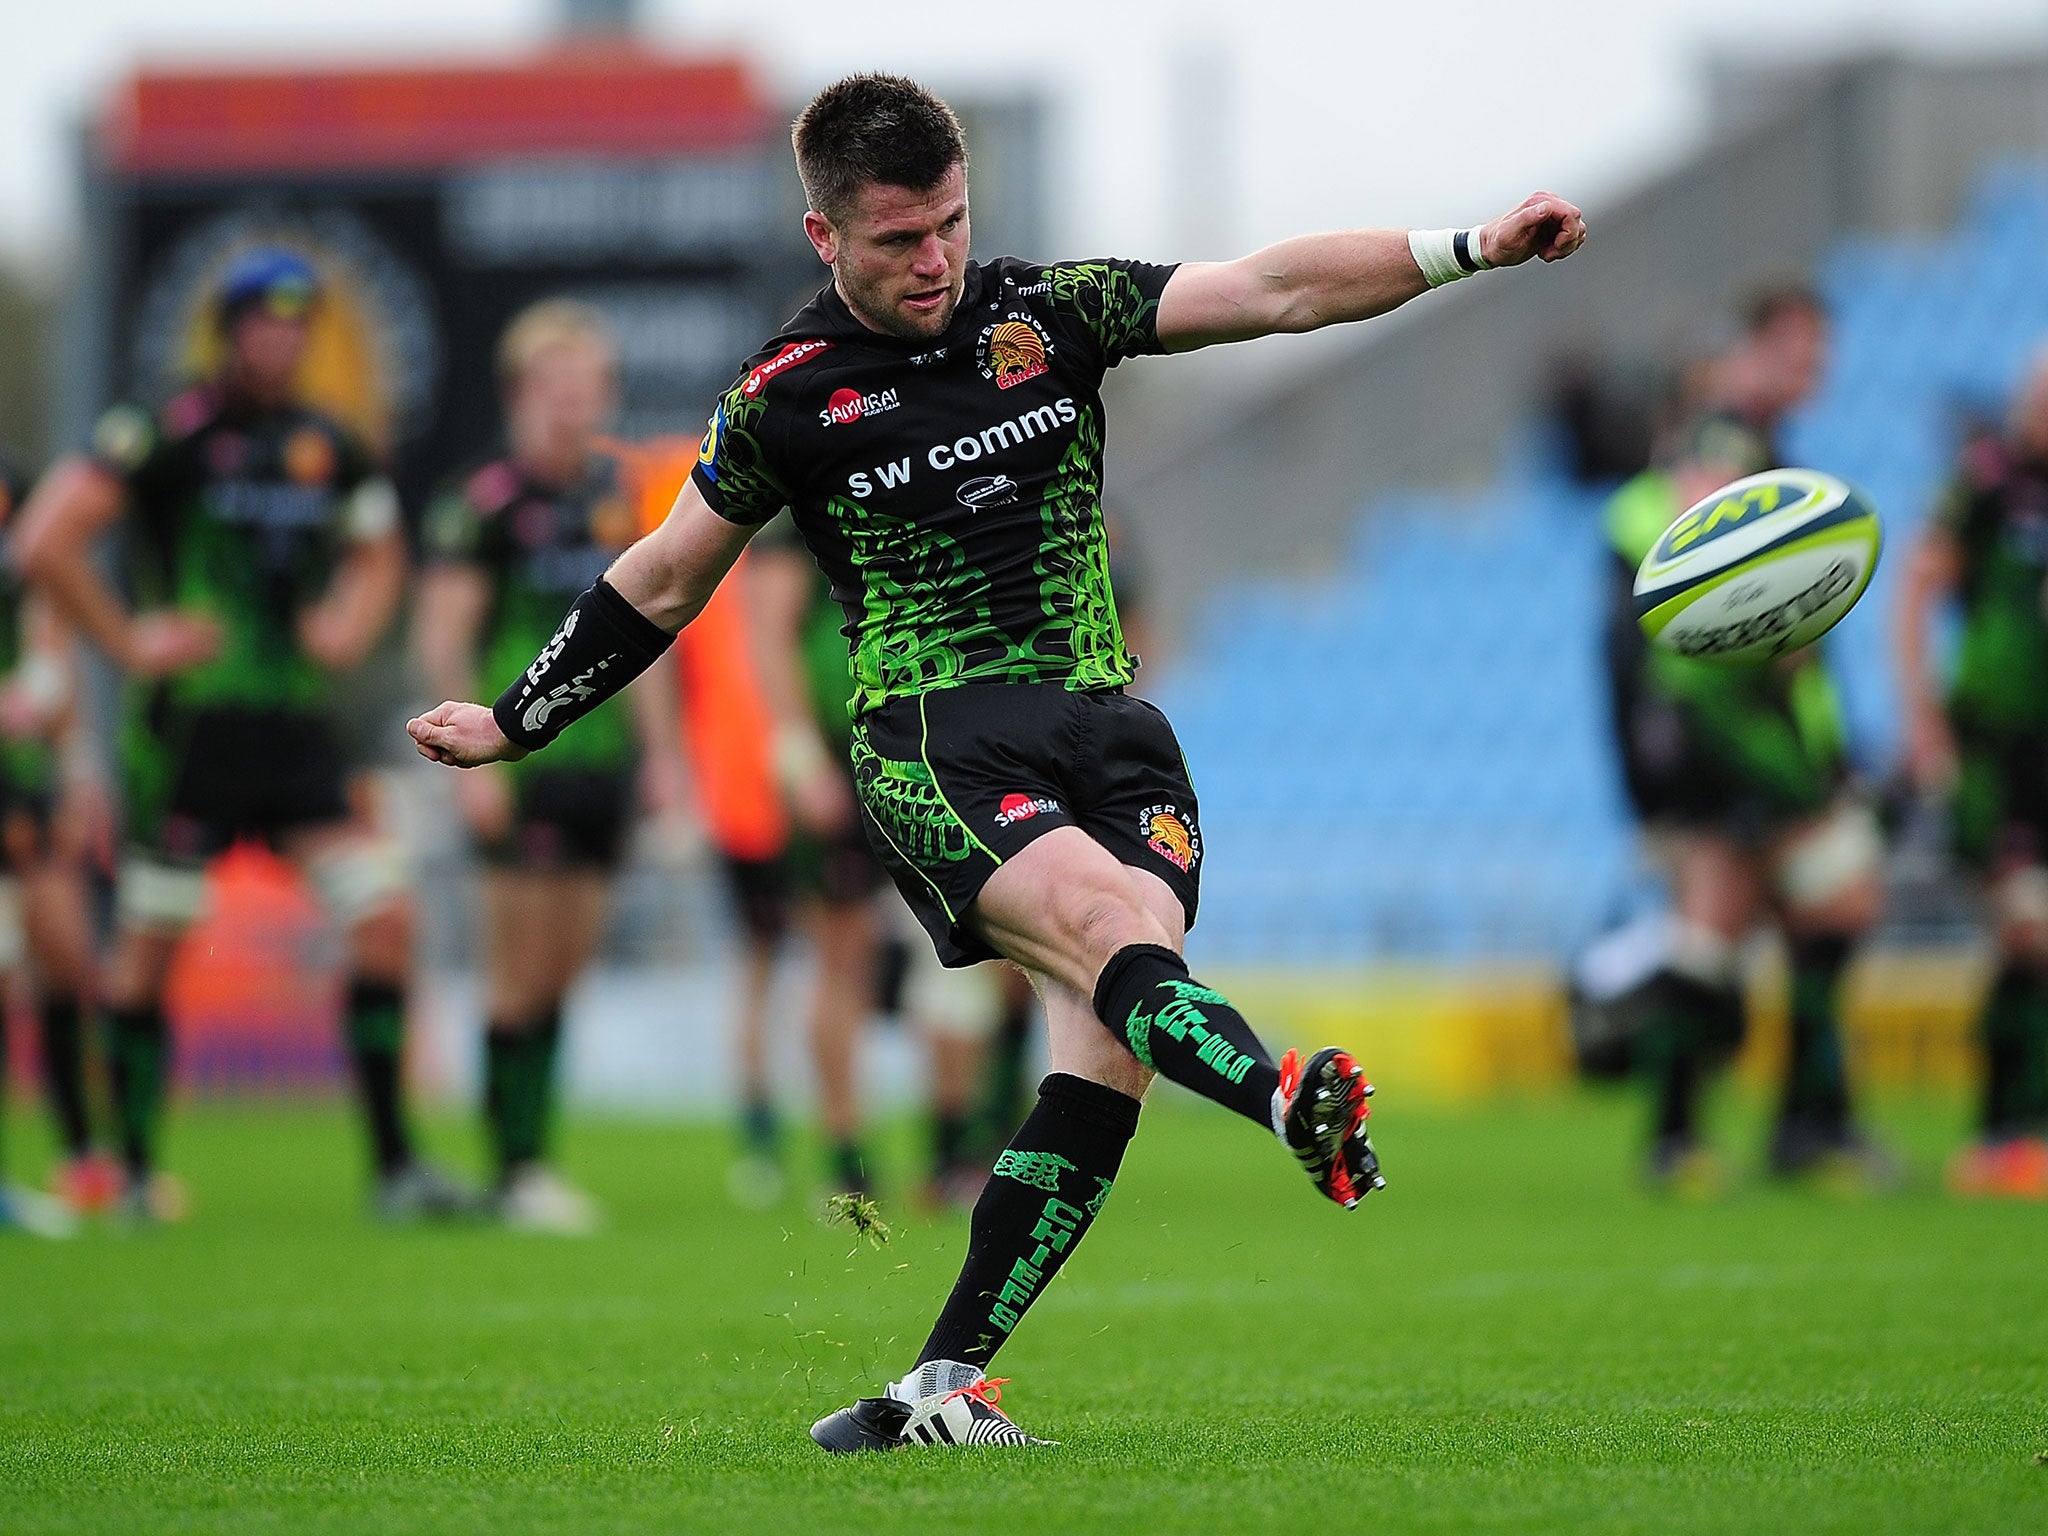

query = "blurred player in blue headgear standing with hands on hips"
[20,246,467,1219]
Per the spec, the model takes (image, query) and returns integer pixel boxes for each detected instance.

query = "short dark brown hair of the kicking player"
[791,74,967,223]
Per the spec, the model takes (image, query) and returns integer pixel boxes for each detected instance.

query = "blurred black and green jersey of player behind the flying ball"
[1606,412,1847,815]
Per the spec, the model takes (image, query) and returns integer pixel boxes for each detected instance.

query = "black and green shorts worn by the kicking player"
[852,682,1202,967]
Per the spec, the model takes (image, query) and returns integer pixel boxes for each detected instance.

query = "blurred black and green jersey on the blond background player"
[420,449,639,776]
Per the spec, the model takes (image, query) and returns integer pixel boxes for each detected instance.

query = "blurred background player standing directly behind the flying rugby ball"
[1608,287,1886,1190]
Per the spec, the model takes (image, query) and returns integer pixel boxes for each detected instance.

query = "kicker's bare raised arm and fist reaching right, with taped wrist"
[1159,193,1585,352]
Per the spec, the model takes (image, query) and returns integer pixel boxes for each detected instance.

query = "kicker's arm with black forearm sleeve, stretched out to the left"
[406,481,754,768]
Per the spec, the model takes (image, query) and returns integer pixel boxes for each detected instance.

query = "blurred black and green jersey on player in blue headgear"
[92,387,397,713]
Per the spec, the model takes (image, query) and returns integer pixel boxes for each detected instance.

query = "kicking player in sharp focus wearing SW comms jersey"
[410,76,1585,1452]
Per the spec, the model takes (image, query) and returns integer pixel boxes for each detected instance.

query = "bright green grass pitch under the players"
[0,1096,2048,1536]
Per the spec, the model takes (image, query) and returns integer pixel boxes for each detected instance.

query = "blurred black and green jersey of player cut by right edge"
[1933,440,2048,735]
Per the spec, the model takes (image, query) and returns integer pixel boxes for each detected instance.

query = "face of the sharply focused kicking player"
[803,166,967,340]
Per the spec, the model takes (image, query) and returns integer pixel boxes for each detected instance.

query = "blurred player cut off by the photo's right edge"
[1896,354,2048,1200]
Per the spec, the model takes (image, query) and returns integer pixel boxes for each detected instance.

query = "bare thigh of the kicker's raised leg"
[969,825,1184,995]
